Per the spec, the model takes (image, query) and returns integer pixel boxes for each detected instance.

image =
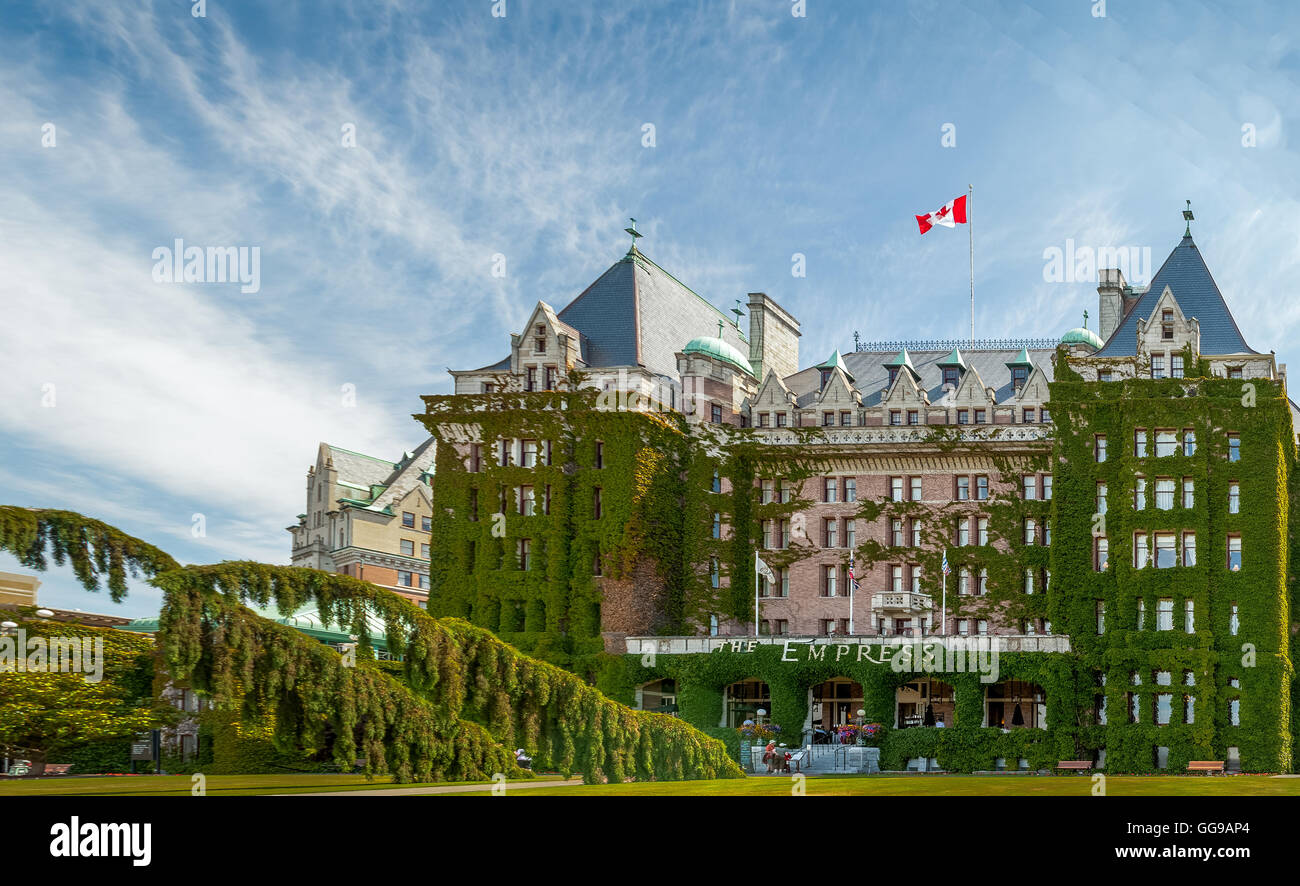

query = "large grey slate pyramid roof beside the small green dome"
[558,248,749,377]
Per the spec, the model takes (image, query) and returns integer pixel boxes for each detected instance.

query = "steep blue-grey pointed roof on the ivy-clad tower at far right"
[1096,234,1258,357]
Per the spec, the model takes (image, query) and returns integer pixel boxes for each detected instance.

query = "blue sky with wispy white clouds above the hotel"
[0,0,1300,614]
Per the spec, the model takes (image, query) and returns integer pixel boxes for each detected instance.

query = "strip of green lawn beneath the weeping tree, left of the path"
[0,773,559,796]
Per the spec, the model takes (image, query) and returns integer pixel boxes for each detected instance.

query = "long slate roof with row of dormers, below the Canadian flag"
[785,348,1053,407]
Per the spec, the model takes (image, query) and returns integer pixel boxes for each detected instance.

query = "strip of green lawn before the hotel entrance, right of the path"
[450,776,1300,796]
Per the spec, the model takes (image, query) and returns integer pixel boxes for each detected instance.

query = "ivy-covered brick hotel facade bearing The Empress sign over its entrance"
[417,224,1300,772]
